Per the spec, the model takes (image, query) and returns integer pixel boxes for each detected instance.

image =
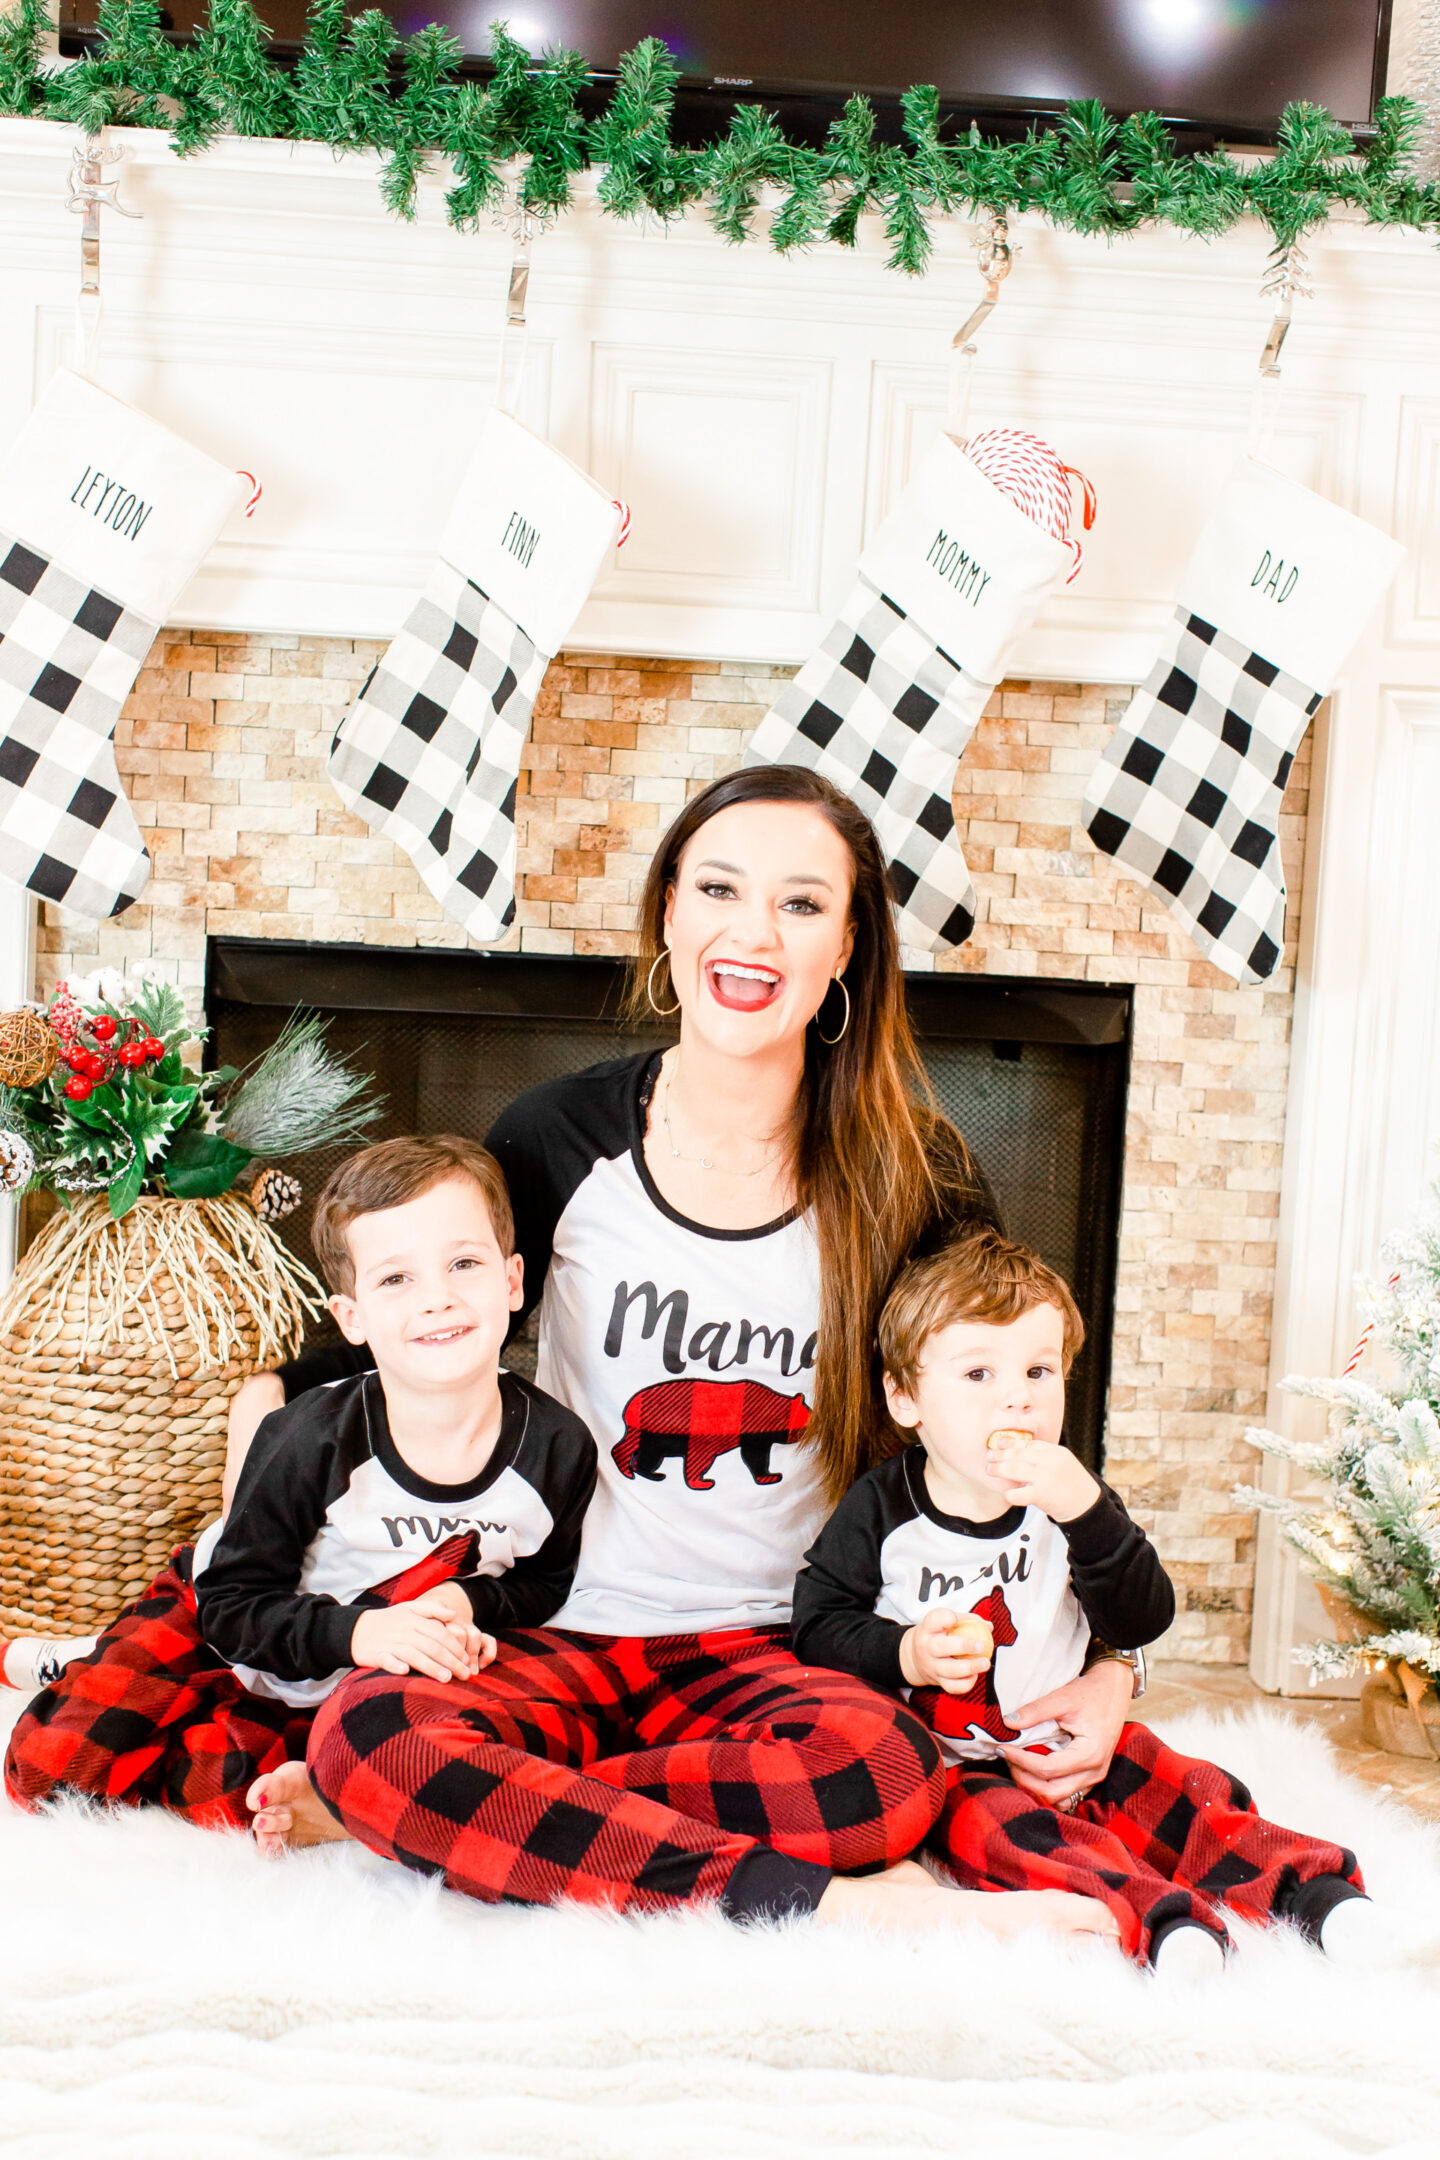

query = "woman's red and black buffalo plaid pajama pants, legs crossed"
[309,1629,946,1918]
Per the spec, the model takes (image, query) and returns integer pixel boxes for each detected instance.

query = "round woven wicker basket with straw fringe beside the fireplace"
[0,1194,320,1635]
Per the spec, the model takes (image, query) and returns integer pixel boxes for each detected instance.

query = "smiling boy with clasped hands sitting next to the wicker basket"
[4,1136,596,1842]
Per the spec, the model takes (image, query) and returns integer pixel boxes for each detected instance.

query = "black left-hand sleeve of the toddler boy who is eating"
[790,1462,913,1687]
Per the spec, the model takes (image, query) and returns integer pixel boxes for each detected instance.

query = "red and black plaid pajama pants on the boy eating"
[926,1724,1364,1963]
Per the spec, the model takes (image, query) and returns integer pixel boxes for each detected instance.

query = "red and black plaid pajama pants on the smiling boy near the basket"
[4,1531,477,1830]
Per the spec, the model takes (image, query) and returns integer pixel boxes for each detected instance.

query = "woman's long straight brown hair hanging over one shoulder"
[628,765,991,1501]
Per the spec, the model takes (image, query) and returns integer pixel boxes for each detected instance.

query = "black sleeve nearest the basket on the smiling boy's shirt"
[194,1389,365,1680]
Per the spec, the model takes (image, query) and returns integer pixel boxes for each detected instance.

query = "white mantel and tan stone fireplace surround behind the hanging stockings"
[0,121,1440,1687]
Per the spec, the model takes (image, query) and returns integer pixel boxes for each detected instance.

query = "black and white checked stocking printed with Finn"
[330,413,622,944]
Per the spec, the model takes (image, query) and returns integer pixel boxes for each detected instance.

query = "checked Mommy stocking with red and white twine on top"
[747,428,1095,948]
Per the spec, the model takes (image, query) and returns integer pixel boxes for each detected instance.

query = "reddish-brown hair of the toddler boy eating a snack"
[879,1229,1086,1399]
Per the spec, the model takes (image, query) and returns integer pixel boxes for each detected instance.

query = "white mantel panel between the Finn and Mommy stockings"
[579,343,831,652]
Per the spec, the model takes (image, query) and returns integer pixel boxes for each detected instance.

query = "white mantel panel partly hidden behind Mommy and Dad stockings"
[866,361,1362,683]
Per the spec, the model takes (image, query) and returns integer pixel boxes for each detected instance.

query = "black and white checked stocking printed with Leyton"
[0,369,242,916]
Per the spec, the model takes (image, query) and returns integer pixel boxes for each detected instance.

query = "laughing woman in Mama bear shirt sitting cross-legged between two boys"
[242,767,1131,1931]
